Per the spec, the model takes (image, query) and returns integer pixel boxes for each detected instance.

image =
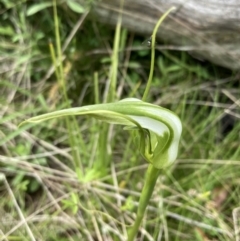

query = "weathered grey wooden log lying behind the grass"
[89,0,240,69]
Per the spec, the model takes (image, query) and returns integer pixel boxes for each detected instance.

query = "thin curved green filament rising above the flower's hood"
[142,7,175,101]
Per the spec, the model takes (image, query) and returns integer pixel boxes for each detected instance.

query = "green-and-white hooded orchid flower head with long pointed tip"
[23,98,182,169]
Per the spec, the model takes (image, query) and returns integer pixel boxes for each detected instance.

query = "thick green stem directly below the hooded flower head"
[128,164,161,241]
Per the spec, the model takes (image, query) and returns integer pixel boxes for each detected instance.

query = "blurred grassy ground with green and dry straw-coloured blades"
[0,0,240,241]
